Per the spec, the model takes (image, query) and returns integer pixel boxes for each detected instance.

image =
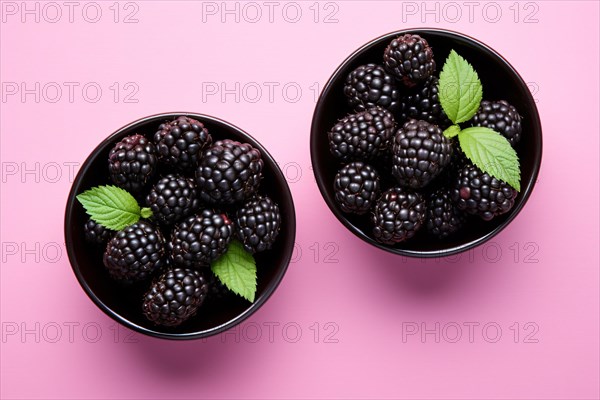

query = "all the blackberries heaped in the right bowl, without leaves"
[328,34,521,245]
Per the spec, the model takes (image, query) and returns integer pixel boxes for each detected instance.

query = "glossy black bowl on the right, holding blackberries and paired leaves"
[310,29,542,257]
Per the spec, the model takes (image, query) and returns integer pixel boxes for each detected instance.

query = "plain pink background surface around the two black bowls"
[0,1,599,399]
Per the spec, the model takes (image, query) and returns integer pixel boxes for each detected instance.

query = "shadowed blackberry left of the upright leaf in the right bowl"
[400,75,452,129]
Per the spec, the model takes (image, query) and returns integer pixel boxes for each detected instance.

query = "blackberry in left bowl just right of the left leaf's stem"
[146,174,200,225]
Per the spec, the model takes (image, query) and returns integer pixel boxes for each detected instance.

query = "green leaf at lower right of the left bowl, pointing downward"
[211,240,256,302]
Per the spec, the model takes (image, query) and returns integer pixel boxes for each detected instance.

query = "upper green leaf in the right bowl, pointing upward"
[438,50,483,124]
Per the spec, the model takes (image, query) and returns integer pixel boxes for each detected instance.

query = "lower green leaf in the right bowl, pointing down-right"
[458,127,521,191]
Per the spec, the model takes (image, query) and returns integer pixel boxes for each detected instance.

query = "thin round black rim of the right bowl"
[310,27,543,258]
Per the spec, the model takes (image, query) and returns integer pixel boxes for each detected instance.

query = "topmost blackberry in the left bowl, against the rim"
[154,116,212,170]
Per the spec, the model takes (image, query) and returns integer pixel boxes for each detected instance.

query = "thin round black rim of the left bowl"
[64,111,296,340]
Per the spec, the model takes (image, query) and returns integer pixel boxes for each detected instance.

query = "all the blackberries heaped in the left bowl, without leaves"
[84,116,281,326]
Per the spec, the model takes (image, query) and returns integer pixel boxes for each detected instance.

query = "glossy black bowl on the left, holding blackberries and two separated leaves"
[65,113,296,339]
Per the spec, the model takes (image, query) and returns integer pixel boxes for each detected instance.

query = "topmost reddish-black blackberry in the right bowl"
[383,34,435,87]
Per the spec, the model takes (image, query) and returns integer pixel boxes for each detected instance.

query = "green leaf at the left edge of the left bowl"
[77,186,140,231]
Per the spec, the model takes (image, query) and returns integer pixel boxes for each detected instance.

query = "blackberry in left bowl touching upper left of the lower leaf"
[167,209,233,267]
